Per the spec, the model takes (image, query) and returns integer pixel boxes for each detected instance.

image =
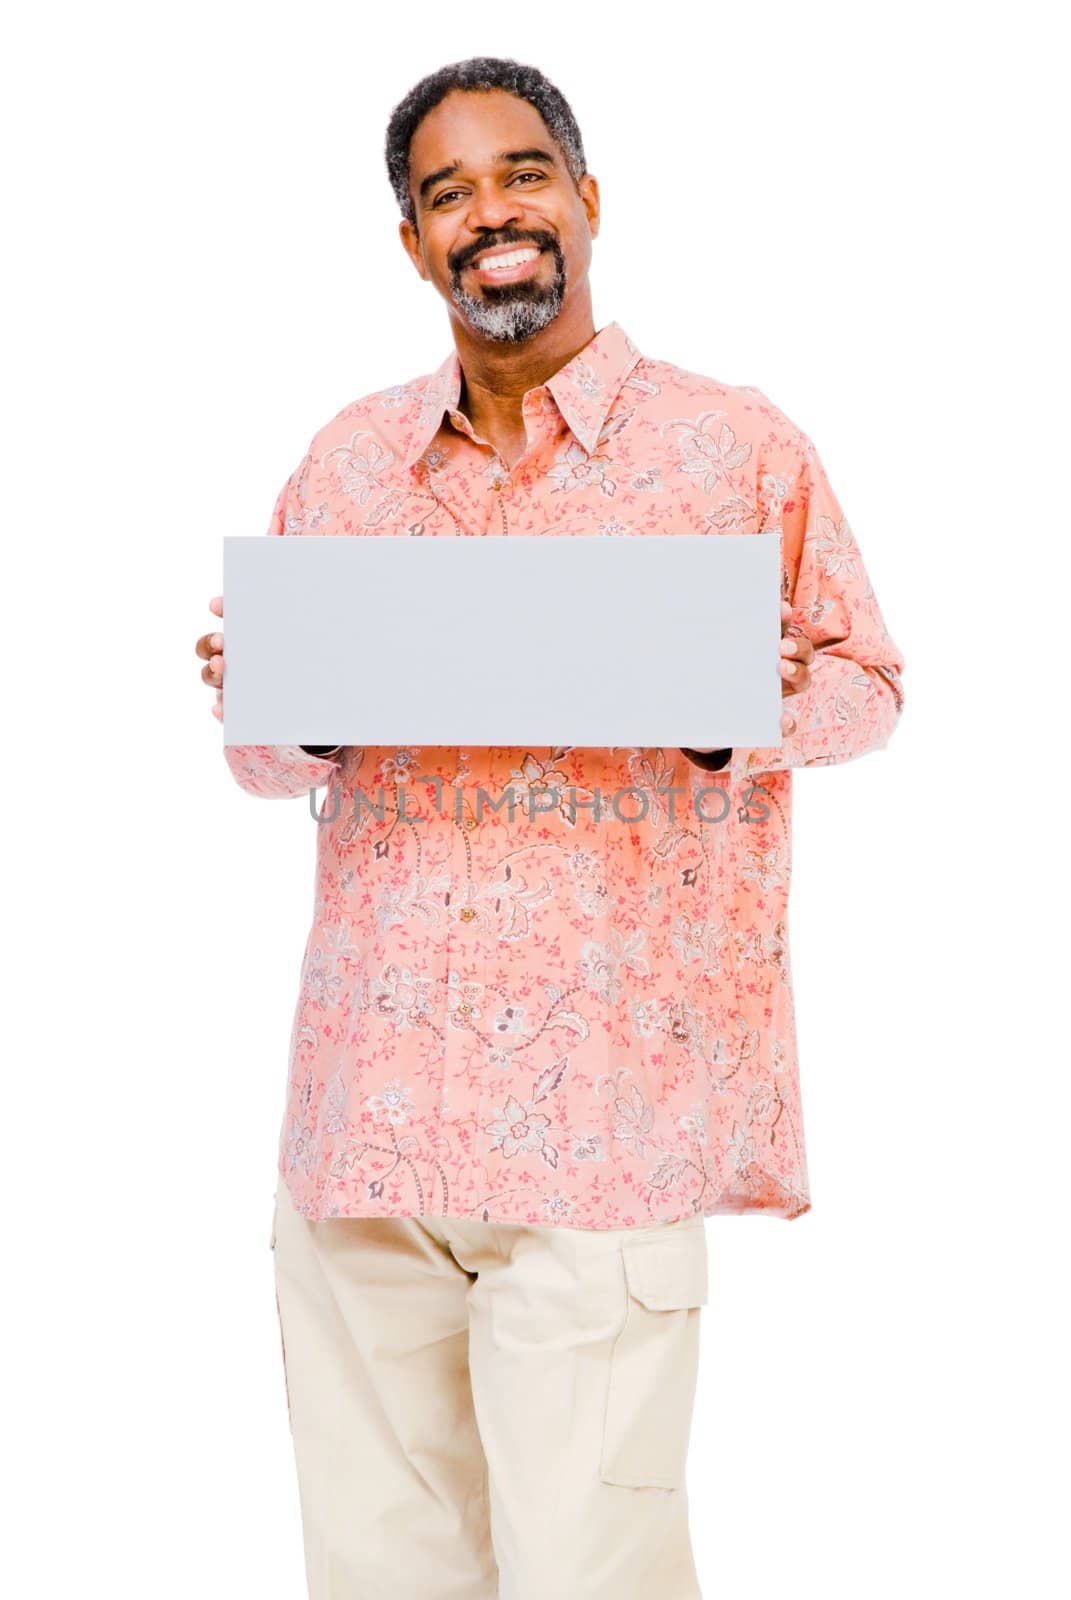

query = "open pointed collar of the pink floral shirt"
[403,322,642,467]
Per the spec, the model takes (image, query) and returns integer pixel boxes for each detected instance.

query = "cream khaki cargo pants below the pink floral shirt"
[272,1179,708,1600]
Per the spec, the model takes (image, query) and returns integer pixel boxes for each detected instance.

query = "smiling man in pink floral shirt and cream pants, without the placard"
[197,58,903,1600]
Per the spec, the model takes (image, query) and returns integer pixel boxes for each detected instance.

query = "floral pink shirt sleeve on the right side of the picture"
[730,395,905,774]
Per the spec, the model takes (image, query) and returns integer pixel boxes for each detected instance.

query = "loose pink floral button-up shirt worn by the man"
[224,322,903,1229]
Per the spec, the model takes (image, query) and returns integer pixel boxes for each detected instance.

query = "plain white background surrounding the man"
[0,0,1071,1600]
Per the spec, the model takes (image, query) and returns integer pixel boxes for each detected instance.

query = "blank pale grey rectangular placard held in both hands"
[223,531,781,749]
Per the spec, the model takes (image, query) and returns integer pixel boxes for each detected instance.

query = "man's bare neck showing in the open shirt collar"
[453,301,596,456]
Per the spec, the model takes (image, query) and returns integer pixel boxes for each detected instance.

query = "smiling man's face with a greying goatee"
[399,90,599,344]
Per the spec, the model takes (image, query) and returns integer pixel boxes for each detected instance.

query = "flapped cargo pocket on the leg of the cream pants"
[599,1218,708,1490]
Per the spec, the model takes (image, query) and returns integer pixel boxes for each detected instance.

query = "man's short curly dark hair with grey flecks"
[384,56,588,227]
